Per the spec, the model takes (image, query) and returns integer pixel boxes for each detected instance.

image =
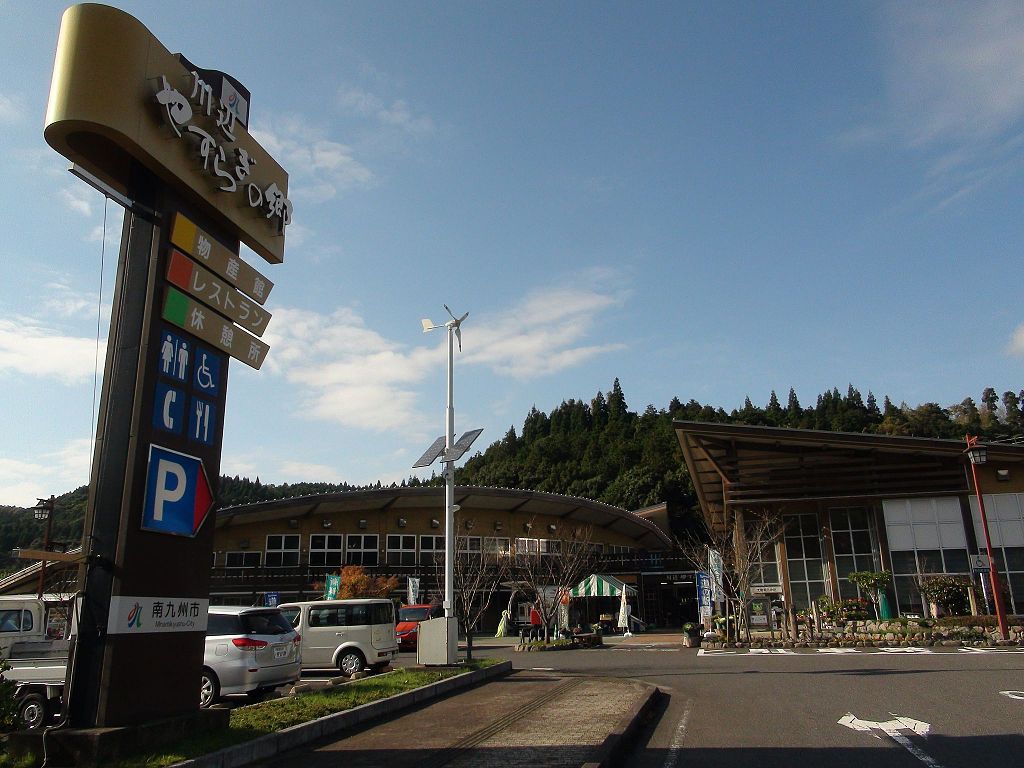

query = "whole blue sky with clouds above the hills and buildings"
[0,0,1024,505]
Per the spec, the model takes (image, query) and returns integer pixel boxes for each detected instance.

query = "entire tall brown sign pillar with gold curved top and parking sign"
[45,5,291,728]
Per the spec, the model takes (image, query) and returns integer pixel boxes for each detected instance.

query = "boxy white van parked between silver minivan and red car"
[279,598,398,675]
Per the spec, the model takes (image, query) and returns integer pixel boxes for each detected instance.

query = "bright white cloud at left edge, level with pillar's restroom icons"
[0,317,105,384]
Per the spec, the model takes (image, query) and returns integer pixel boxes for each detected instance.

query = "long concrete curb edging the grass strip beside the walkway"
[171,660,520,768]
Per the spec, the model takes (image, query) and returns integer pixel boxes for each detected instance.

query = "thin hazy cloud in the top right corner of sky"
[841,0,1024,208]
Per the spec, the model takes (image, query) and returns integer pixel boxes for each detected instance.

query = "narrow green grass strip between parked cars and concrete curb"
[113,658,501,768]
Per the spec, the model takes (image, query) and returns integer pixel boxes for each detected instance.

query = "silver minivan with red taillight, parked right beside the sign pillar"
[200,605,301,708]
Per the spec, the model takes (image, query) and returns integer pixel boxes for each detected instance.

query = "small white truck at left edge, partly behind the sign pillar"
[0,595,71,729]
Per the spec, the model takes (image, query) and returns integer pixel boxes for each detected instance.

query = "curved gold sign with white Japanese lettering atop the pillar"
[43,3,293,264]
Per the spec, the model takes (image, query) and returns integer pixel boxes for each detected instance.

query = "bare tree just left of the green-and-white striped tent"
[515,522,596,642]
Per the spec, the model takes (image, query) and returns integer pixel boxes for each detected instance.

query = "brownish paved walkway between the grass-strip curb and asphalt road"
[246,671,653,768]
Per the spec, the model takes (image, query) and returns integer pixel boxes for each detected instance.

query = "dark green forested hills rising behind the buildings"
[0,379,1024,572]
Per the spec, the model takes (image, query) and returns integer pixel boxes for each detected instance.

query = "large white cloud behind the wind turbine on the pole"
[258,275,624,432]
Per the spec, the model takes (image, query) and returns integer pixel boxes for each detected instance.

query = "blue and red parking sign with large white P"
[142,444,213,537]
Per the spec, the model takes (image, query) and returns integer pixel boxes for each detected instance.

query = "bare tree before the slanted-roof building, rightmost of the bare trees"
[677,510,783,641]
